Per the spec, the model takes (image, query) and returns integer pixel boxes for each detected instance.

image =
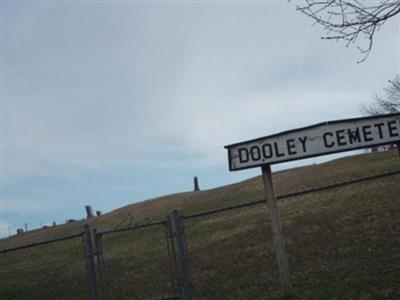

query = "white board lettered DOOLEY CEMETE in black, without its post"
[225,113,400,171]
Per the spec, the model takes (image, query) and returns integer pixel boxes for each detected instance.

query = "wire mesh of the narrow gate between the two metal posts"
[98,224,176,300]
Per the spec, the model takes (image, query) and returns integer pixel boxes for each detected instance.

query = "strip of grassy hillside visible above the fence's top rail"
[0,150,400,249]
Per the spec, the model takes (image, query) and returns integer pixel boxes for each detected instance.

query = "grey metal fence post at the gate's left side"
[83,224,98,300]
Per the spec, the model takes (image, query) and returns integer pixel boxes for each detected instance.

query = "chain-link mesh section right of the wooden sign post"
[281,177,400,299]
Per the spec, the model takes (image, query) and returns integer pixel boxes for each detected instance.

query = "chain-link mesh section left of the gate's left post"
[0,237,90,300]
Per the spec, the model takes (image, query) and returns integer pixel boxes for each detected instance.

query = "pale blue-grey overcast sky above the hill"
[0,0,400,236]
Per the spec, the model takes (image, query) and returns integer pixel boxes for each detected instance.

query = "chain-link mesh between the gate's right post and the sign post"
[185,203,279,299]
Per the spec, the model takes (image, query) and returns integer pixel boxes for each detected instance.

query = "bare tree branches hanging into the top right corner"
[297,0,400,62]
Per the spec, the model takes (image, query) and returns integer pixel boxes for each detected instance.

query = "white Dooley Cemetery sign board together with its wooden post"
[225,113,400,293]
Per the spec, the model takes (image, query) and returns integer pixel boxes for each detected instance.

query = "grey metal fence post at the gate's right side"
[172,210,193,300]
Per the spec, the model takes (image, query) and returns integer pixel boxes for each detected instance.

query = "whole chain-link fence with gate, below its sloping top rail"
[0,171,400,300]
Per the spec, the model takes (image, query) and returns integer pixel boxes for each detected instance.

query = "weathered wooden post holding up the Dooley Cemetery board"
[261,165,292,294]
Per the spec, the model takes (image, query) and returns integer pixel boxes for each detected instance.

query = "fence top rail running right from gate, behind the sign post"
[182,170,400,219]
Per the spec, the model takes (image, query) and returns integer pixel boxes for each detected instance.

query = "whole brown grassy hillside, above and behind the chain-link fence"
[0,151,400,299]
